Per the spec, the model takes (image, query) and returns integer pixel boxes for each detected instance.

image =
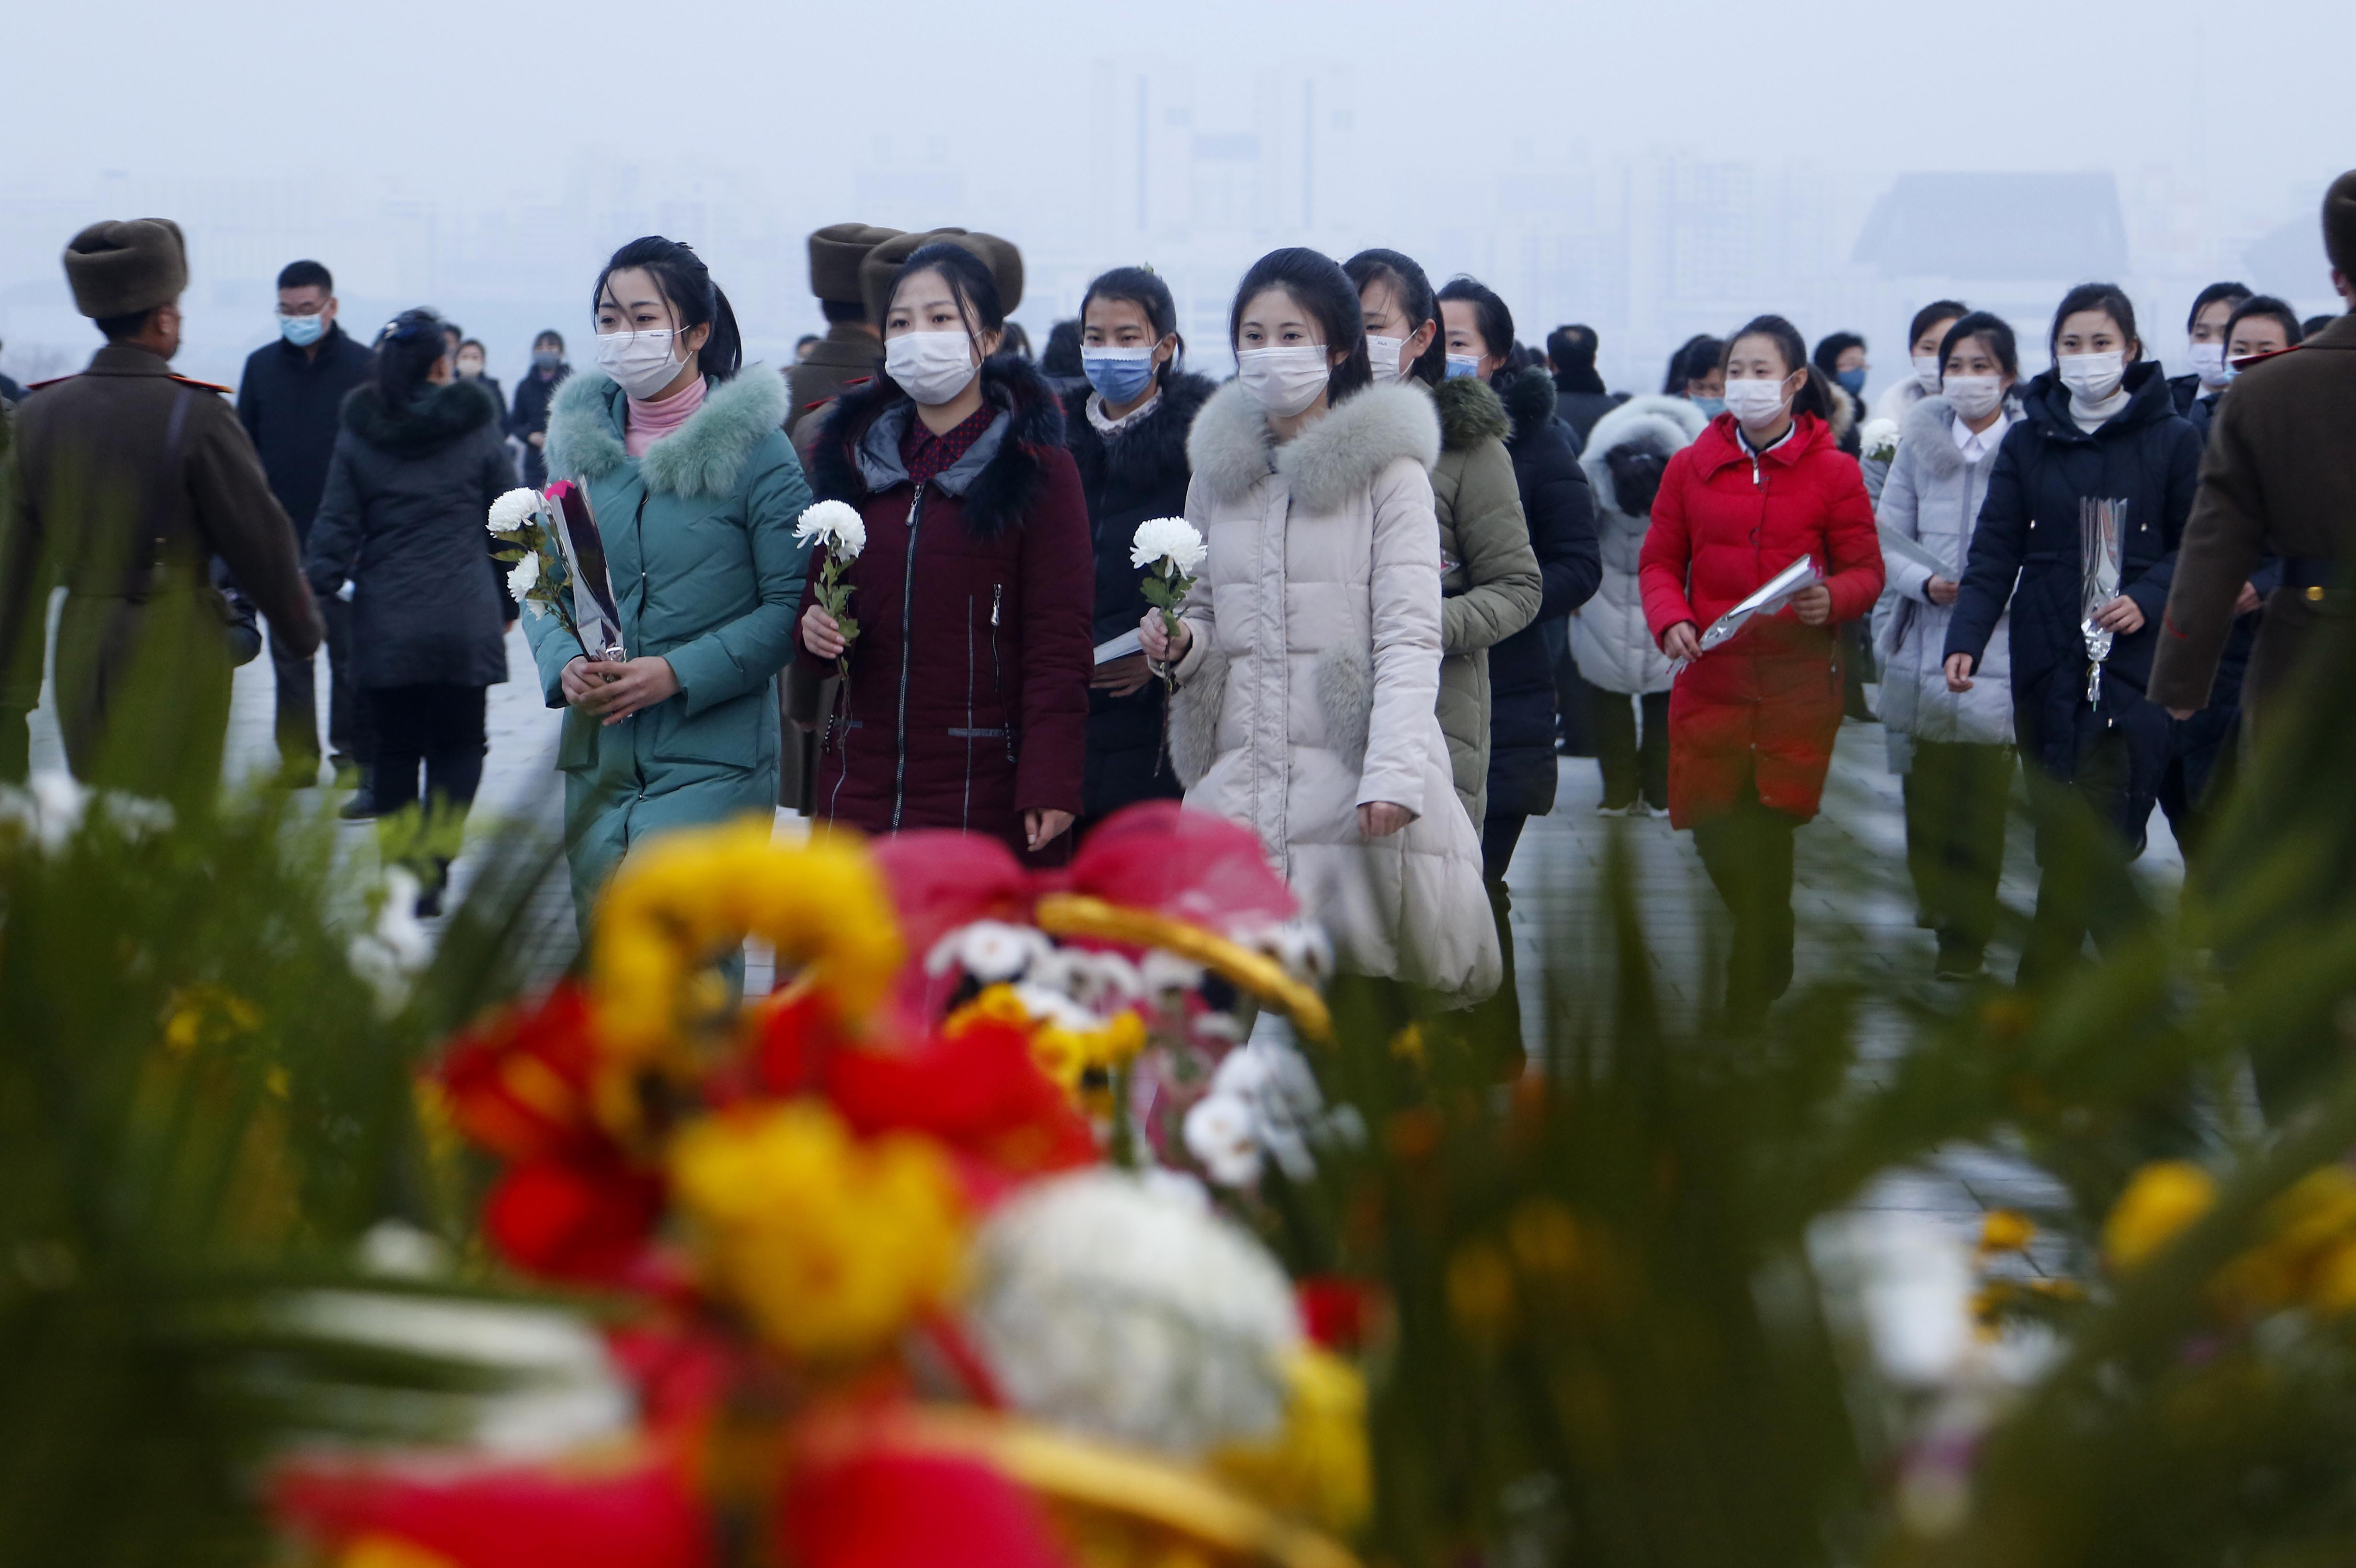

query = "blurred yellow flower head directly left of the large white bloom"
[671,1100,966,1361]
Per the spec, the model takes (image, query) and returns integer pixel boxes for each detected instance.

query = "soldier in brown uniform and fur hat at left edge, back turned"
[0,219,320,805]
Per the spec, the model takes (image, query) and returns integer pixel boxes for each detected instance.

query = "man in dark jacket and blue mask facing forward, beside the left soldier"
[238,261,375,786]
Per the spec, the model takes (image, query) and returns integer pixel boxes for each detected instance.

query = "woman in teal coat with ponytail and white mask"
[528,236,810,918]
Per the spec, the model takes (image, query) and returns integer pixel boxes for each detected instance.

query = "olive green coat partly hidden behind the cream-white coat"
[1432,377,1546,833]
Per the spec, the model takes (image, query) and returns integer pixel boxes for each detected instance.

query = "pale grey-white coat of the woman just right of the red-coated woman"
[1875,384,2012,772]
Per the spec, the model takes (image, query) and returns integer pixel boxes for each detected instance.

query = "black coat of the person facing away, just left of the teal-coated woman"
[304,382,516,687]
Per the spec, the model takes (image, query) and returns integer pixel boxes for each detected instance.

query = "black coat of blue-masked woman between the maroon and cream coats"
[1063,372,1216,817]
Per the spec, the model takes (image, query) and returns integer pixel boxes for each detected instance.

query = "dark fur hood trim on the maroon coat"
[810,353,1065,539]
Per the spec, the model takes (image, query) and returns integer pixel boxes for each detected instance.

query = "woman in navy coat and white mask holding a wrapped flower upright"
[1946,283,2201,984]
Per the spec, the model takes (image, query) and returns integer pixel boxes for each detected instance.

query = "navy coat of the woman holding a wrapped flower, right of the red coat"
[1946,360,2201,779]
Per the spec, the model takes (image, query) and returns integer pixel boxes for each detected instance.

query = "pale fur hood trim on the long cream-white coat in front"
[1185,382,1440,513]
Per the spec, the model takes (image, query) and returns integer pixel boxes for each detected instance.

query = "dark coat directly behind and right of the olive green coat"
[1489,370,1604,817]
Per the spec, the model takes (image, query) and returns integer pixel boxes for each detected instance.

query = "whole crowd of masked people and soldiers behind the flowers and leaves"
[0,174,2356,1022]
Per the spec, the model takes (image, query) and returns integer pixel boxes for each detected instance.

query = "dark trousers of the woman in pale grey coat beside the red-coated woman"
[1904,742,2012,965]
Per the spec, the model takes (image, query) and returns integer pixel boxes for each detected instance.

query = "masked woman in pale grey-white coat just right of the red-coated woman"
[1878,311,2019,980]
